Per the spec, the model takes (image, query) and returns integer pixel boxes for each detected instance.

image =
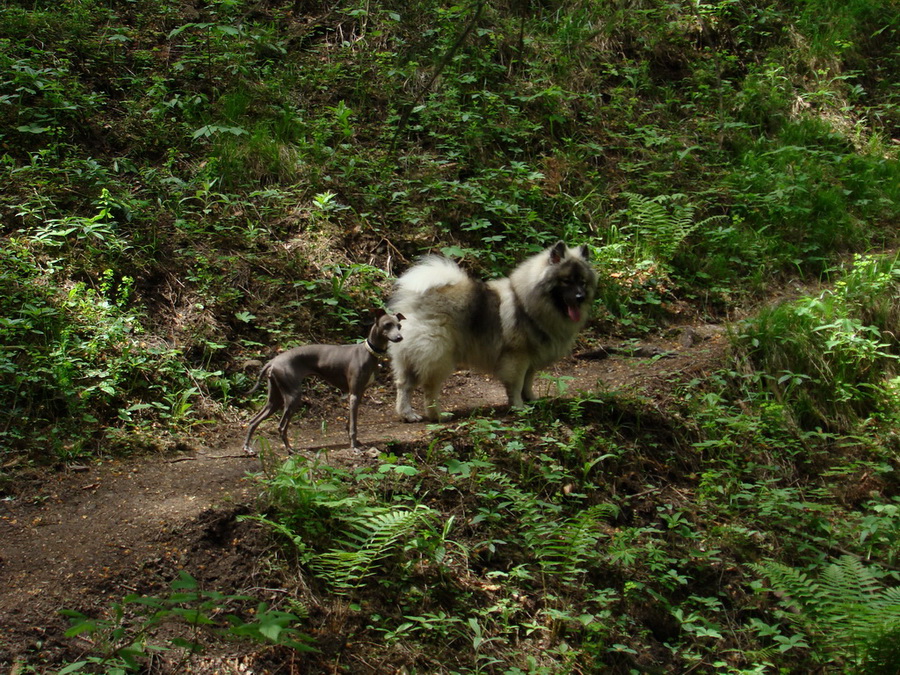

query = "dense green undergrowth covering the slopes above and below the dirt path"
[0,0,900,673]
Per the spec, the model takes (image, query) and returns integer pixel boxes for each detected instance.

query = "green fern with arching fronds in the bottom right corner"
[756,556,900,675]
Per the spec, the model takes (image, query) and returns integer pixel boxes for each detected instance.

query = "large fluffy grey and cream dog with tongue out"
[388,241,597,422]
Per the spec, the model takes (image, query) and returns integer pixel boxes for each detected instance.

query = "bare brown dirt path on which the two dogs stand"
[0,324,727,674]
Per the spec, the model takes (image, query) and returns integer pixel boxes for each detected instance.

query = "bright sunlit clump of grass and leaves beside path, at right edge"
[738,257,900,431]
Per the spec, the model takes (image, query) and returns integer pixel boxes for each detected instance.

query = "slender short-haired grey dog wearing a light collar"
[244,309,404,455]
